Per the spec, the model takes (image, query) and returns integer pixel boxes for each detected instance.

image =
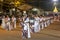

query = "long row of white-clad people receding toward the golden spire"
[20,15,53,38]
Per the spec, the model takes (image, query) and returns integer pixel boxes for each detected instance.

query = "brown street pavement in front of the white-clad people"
[0,22,60,40]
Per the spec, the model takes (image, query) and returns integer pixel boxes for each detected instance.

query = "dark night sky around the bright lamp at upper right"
[27,0,60,11]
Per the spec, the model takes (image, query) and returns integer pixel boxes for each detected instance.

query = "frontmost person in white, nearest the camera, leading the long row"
[23,16,31,38]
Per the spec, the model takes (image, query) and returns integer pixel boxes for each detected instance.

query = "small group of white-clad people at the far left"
[1,16,16,30]
